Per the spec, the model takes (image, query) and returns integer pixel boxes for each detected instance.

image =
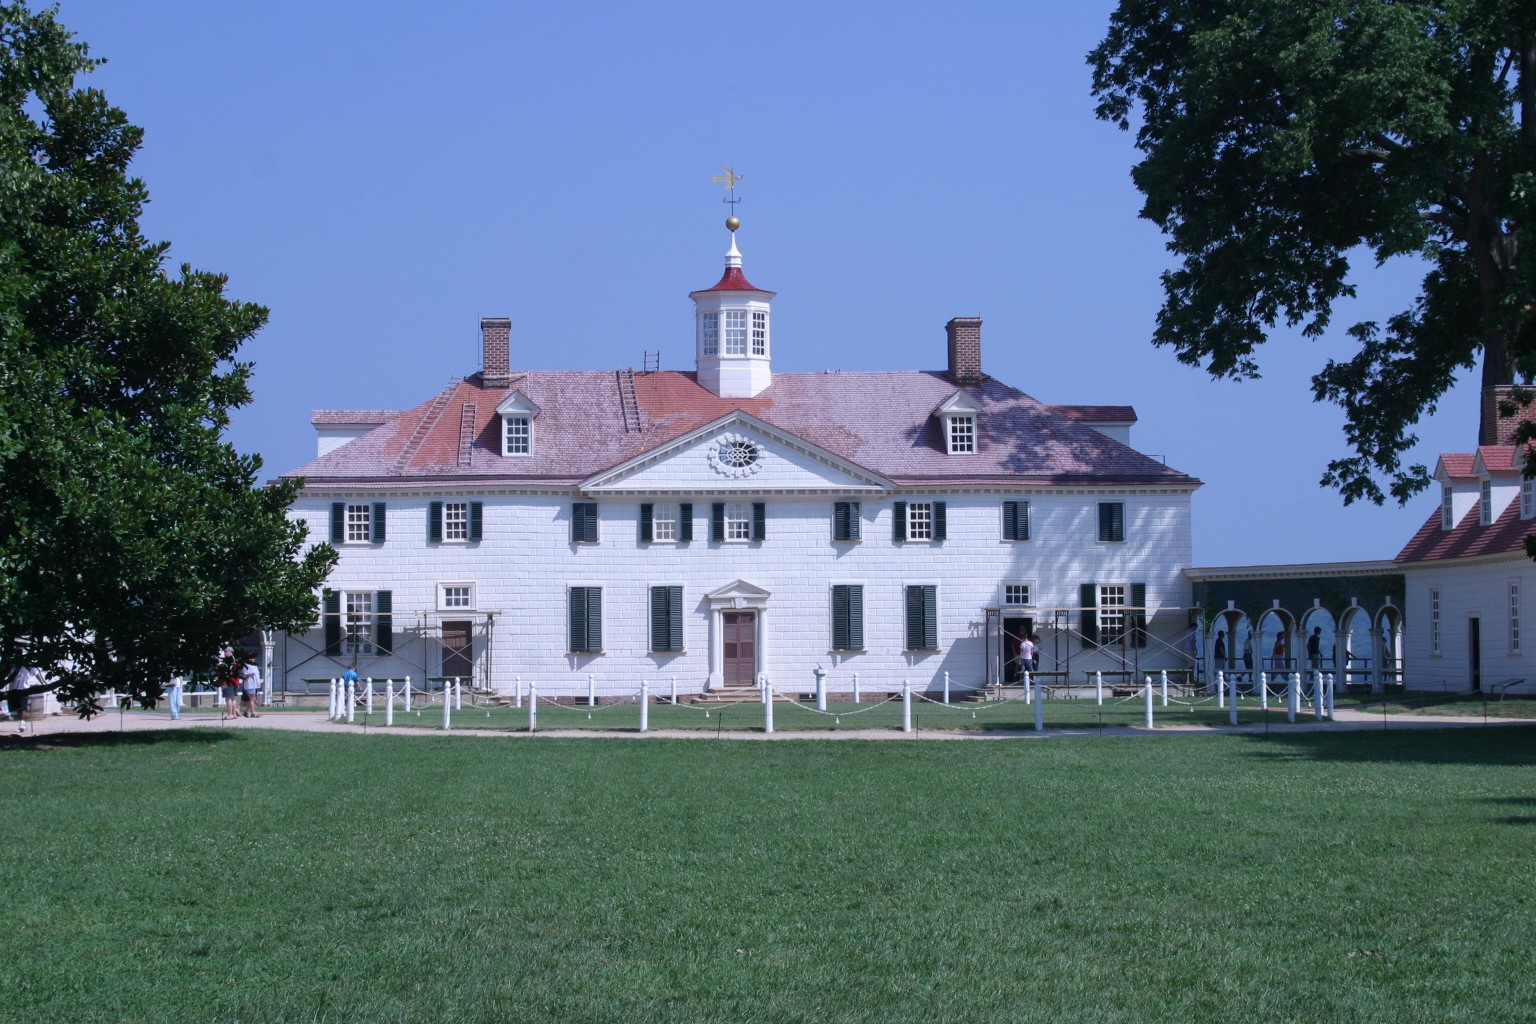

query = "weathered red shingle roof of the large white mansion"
[290,370,1200,488]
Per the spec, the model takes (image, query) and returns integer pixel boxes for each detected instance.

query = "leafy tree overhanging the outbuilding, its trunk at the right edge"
[1087,0,1536,504]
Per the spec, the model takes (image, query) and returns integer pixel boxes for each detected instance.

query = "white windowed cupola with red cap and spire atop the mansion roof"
[688,216,774,398]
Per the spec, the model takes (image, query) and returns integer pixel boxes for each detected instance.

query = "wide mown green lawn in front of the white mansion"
[0,726,1536,1024]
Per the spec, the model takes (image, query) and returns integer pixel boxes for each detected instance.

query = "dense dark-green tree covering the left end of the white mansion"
[0,3,335,714]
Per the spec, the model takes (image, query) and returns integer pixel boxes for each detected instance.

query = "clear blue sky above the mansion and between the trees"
[44,0,1476,565]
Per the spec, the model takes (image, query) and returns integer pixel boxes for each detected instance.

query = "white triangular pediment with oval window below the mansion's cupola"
[582,413,892,496]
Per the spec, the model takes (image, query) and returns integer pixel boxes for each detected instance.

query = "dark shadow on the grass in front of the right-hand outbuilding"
[1241,726,1536,767]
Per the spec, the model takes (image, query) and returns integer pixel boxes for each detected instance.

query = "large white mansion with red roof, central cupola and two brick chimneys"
[275,229,1200,695]
